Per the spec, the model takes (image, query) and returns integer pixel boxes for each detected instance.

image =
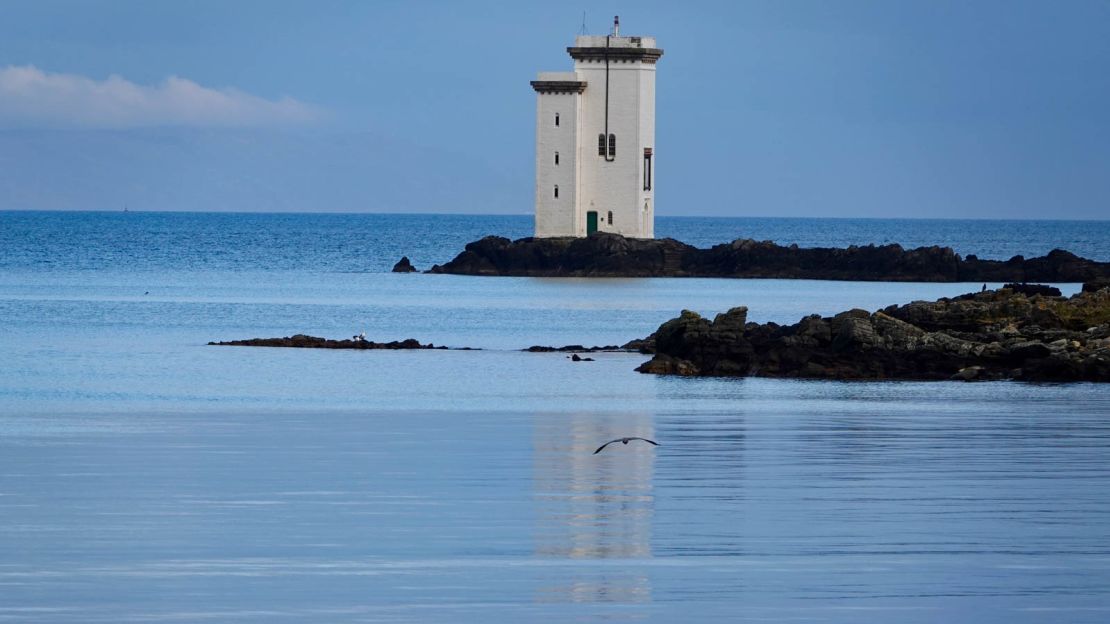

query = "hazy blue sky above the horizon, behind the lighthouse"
[0,0,1110,219]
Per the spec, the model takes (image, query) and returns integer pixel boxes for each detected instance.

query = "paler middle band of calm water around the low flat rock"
[0,271,1079,411]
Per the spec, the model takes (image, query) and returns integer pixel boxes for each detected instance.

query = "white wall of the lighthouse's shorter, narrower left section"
[536,89,585,236]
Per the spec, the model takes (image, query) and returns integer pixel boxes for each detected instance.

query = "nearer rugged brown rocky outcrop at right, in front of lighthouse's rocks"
[637,283,1110,382]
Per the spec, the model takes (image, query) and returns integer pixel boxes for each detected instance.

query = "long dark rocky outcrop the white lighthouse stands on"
[431,232,1110,282]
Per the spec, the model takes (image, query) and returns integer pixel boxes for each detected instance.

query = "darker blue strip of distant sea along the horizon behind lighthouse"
[0,211,1110,272]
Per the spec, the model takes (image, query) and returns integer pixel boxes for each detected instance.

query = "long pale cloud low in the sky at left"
[0,66,317,128]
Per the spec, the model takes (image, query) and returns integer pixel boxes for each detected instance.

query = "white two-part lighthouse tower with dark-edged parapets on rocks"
[532,18,663,239]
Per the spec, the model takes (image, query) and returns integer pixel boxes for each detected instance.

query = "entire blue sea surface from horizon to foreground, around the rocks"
[0,212,1110,623]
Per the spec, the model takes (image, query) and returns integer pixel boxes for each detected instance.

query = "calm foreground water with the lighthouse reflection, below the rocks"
[0,390,1110,622]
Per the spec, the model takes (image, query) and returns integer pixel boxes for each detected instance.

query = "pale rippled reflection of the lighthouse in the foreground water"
[533,414,655,602]
